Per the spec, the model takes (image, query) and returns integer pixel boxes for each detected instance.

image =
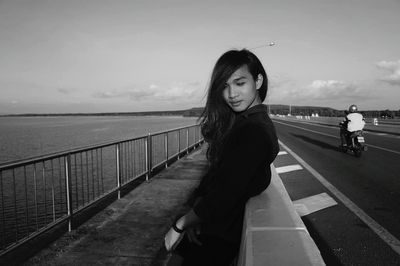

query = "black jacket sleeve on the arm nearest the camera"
[193,125,274,221]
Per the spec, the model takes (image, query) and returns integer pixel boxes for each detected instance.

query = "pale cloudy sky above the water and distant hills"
[0,0,400,114]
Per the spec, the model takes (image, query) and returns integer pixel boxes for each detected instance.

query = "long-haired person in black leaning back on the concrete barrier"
[165,49,279,266]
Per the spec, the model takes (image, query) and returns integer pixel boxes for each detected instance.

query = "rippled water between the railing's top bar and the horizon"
[0,116,196,163]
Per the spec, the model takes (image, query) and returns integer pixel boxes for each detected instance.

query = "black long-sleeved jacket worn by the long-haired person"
[193,104,279,244]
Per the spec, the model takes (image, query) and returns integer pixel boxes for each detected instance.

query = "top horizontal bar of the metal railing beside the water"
[0,124,200,171]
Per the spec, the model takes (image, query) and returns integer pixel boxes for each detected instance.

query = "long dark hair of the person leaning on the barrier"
[200,49,268,166]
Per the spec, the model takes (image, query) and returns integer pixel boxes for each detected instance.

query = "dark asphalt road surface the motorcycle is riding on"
[274,119,400,265]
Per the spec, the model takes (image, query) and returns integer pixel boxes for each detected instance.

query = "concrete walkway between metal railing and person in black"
[24,146,207,265]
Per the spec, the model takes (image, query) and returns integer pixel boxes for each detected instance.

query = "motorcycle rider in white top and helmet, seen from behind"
[340,104,365,146]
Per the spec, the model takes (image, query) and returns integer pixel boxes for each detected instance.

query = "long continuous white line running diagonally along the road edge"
[278,140,400,255]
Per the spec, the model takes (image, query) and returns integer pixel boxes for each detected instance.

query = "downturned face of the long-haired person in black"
[222,65,263,113]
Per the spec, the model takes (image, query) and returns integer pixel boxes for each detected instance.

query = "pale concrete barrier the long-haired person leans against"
[237,165,325,266]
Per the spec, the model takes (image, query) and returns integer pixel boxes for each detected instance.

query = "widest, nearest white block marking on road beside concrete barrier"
[293,192,337,216]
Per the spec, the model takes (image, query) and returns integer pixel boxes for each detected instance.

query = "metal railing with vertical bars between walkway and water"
[0,125,203,256]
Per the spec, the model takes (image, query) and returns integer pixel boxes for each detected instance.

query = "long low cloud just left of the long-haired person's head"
[93,82,204,102]
